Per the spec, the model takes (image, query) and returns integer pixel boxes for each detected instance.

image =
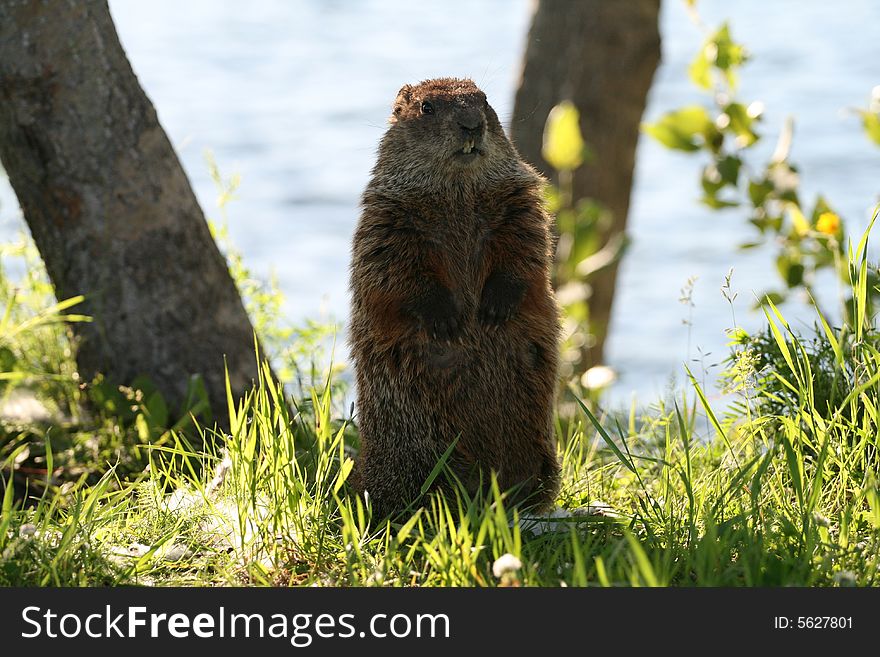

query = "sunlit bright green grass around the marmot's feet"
[0,310,880,586]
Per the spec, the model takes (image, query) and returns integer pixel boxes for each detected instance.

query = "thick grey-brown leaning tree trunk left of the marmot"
[0,0,257,417]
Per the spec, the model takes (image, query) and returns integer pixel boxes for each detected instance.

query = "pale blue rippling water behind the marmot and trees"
[0,0,880,402]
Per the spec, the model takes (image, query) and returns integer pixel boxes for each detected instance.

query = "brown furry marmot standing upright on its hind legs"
[349,78,560,517]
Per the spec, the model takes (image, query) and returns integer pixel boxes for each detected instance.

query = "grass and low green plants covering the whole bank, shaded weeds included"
[0,218,880,586]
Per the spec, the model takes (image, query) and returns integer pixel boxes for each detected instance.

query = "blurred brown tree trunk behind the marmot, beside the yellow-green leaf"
[511,0,660,371]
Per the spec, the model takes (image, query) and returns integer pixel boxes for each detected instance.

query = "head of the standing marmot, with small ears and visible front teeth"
[380,78,512,183]
